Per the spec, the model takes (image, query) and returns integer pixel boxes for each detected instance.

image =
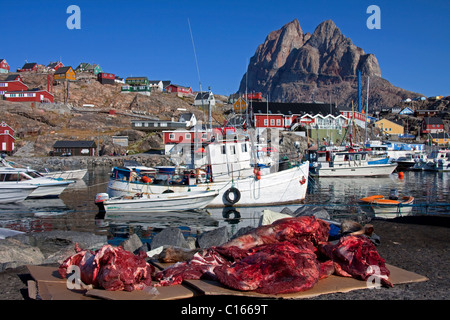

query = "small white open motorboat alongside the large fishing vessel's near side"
[95,190,219,213]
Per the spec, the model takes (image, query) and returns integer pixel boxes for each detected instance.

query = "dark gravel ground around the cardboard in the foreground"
[0,216,450,300]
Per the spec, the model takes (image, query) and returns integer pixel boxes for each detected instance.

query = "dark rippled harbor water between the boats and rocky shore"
[0,167,450,244]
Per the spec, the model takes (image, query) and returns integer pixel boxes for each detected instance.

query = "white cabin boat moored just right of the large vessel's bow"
[309,150,397,177]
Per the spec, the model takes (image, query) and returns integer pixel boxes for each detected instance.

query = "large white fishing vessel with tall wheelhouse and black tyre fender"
[107,130,309,207]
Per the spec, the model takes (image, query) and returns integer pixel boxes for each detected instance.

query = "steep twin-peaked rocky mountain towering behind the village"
[238,20,420,110]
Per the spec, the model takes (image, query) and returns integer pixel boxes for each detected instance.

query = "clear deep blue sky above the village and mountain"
[0,0,450,96]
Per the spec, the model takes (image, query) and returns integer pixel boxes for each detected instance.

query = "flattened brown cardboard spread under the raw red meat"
[28,264,428,300]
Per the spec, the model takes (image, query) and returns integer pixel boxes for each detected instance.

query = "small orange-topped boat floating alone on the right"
[359,189,414,219]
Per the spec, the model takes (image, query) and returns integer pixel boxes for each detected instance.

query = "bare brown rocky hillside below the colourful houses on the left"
[0,72,224,157]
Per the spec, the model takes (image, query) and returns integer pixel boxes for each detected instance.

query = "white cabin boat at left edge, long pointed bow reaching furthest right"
[0,167,74,198]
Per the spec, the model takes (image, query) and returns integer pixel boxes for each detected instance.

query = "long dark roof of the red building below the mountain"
[249,102,340,116]
